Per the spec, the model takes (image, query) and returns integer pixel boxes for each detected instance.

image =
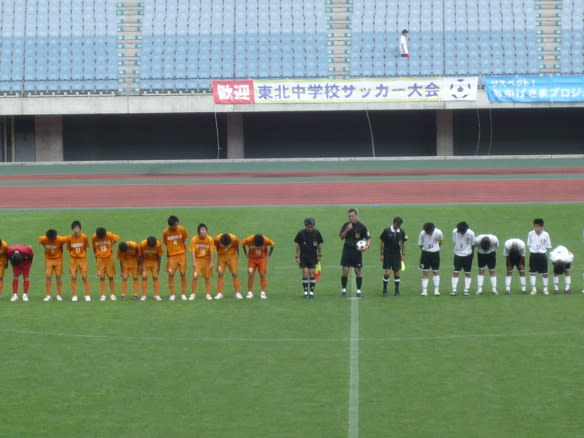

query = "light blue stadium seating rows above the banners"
[0,0,584,94]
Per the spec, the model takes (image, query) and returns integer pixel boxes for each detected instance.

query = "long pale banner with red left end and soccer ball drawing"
[213,77,478,104]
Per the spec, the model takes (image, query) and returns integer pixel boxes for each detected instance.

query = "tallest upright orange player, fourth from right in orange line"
[162,216,189,301]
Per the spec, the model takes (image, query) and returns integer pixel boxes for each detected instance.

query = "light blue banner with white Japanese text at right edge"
[484,76,584,103]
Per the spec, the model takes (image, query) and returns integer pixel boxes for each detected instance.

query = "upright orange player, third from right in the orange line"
[189,224,215,300]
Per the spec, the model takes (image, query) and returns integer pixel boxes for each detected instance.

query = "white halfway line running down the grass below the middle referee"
[348,300,359,438]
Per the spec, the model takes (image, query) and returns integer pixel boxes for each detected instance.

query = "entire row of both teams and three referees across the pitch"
[0,212,574,301]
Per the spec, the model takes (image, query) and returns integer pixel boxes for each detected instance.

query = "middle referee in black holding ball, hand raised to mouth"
[339,208,371,298]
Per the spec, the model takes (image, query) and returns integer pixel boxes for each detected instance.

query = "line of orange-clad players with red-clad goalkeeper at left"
[0,216,274,301]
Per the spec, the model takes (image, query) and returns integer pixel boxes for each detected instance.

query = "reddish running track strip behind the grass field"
[0,168,584,209]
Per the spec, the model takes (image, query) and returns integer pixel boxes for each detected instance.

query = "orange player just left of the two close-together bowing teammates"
[91,227,120,301]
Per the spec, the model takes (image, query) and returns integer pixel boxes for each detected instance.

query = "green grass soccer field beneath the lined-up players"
[0,204,584,438]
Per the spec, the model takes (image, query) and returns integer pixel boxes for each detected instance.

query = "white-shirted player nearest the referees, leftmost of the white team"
[418,222,444,296]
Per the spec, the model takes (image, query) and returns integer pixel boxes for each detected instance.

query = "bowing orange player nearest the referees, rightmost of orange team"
[241,234,274,299]
